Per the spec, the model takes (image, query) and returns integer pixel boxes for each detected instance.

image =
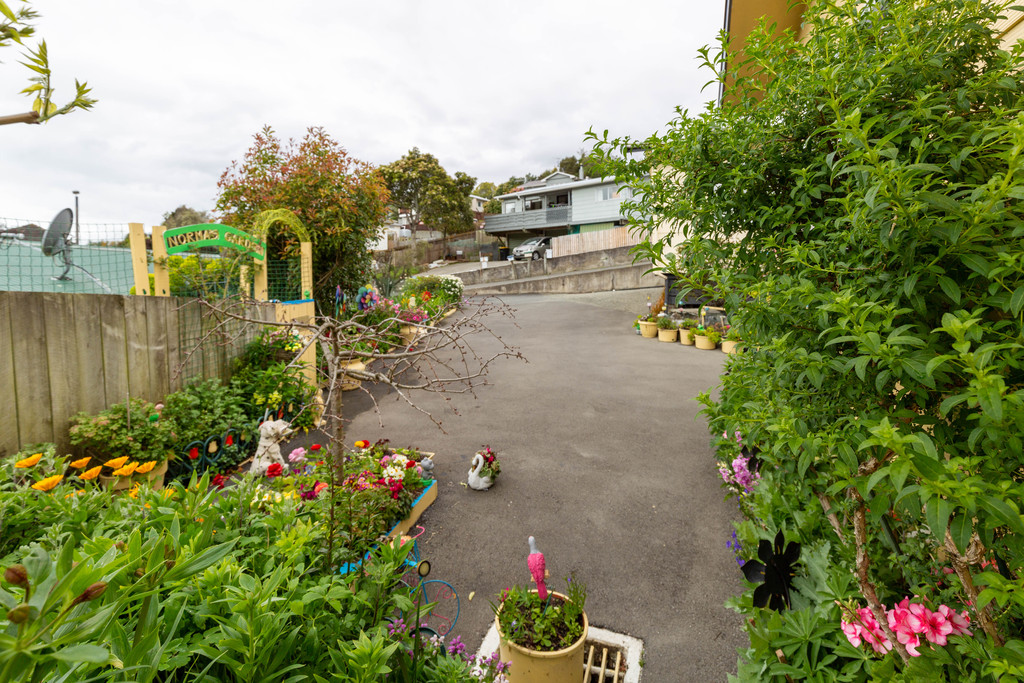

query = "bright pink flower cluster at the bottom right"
[843,598,974,657]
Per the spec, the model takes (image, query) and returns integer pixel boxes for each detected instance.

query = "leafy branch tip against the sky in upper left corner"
[0,0,96,125]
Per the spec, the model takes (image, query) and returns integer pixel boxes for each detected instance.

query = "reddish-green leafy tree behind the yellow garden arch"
[216,126,388,314]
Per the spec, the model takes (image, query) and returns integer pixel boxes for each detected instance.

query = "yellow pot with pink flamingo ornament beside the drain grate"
[492,537,589,683]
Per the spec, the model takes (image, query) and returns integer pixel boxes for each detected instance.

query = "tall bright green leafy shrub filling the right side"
[593,0,1024,683]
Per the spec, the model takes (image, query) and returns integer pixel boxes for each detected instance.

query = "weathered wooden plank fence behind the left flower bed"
[0,292,274,458]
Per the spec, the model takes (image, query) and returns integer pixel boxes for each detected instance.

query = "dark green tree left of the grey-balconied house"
[381,147,476,236]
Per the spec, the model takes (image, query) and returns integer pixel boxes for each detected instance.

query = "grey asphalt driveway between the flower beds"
[344,291,745,683]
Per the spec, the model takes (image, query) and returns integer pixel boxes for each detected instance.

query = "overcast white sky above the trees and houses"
[0,0,724,232]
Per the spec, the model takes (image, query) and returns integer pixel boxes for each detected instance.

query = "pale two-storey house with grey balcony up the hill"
[483,171,630,247]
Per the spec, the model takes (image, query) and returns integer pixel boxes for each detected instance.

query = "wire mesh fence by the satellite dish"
[0,217,133,294]
